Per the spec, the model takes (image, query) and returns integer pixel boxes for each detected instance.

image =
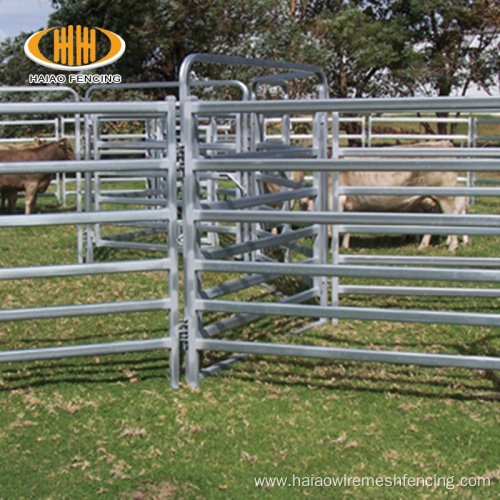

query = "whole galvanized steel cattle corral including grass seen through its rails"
[0,55,500,387]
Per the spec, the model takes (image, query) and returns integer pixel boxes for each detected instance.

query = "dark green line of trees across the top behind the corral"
[0,0,500,101]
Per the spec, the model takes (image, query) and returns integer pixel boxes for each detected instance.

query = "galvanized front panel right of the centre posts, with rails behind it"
[183,98,500,386]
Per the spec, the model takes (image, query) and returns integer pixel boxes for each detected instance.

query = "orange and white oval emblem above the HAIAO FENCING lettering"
[24,25,125,71]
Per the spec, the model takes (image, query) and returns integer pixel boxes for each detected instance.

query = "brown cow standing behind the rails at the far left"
[0,139,75,214]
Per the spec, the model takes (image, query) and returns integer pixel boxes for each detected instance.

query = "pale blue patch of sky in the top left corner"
[0,0,54,41]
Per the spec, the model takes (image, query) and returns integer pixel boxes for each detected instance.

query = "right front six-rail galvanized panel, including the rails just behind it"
[183,93,500,386]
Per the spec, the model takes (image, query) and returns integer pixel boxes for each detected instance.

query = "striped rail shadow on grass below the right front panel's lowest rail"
[201,358,500,401]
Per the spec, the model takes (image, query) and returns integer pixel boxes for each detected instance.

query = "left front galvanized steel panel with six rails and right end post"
[0,98,180,387]
